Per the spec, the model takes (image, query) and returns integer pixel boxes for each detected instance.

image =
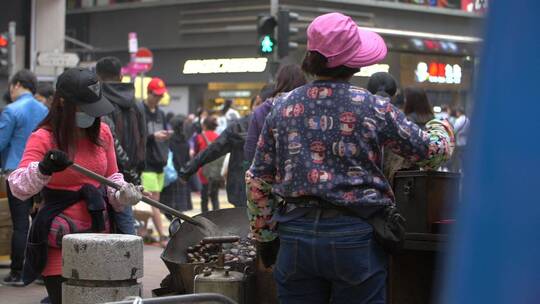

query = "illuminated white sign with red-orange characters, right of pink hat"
[414,61,462,84]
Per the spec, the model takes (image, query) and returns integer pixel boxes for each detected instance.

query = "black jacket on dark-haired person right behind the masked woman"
[103,82,146,184]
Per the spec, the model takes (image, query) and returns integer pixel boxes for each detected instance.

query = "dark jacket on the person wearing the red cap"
[142,103,169,173]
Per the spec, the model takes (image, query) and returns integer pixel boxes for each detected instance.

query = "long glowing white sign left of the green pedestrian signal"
[182,58,268,74]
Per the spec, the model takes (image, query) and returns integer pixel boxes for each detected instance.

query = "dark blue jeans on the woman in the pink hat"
[274,216,388,304]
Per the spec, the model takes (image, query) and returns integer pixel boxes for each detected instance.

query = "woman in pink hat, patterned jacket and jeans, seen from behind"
[246,13,453,304]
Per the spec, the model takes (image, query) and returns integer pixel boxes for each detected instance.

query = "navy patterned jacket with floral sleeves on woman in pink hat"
[246,81,454,242]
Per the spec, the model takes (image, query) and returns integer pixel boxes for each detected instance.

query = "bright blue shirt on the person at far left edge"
[0,93,48,170]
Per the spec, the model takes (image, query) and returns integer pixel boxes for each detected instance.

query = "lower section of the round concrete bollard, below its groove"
[62,282,142,304]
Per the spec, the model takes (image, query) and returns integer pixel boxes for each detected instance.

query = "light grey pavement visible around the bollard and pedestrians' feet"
[0,191,232,304]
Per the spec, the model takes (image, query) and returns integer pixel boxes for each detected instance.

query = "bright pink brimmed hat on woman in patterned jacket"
[307,13,387,68]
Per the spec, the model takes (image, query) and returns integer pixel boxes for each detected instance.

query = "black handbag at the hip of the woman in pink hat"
[366,205,407,254]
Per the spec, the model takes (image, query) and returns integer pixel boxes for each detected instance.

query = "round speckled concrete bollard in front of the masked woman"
[62,233,143,304]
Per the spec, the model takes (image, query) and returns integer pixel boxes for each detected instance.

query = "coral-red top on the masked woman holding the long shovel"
[19,123,118,276]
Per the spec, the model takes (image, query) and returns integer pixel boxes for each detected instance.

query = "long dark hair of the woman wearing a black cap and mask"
[38,93,101,156]
